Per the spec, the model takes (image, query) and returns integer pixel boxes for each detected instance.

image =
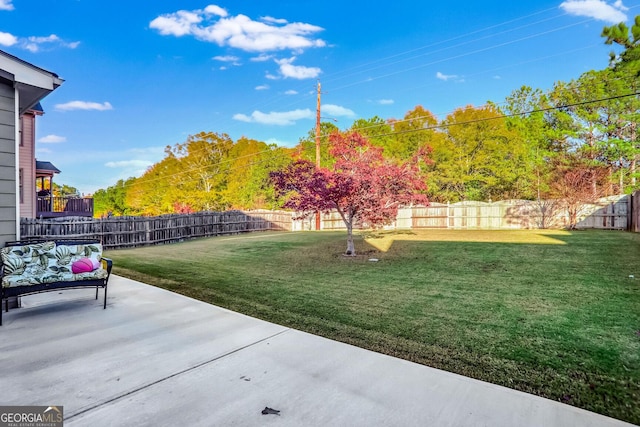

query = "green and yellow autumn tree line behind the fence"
[94,15,640,216]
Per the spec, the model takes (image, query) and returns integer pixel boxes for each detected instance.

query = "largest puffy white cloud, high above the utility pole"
[149,5,326,52]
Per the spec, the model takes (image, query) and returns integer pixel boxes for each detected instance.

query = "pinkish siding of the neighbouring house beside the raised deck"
[19,113,36,218]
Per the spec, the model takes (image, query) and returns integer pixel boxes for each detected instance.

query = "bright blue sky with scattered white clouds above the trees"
[0,0,640,193]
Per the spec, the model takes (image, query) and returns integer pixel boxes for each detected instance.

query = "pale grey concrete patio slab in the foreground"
[0,276,631,427]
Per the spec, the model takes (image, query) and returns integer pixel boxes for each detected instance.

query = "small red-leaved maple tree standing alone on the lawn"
[271,132,429,256]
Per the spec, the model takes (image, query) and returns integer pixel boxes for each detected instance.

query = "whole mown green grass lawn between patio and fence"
[106,230,640,424]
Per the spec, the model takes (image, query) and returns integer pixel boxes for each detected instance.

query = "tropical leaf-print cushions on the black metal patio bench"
[0,242,108,287]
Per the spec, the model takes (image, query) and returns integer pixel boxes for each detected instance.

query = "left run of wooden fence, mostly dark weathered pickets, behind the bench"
[20,211,291,249]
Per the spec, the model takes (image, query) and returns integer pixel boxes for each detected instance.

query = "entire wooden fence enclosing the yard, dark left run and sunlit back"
[20,196,640,249]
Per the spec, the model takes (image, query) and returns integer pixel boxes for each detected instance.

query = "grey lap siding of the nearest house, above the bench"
[0,80,17,246]
